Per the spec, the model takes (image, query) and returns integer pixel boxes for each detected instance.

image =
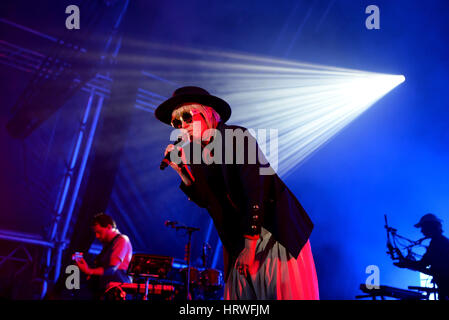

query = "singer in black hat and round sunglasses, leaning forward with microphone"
[155,87,319,300]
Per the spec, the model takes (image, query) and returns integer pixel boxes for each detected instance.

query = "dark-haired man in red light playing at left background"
[76,213,133,296]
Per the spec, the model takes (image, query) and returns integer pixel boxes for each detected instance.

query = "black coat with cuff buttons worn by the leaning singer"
[180,123,313,276]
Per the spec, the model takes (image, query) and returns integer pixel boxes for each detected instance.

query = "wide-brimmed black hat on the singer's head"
[154,86,231,125]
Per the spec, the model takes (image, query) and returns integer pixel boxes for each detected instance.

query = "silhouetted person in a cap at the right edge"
[394,213,449,300]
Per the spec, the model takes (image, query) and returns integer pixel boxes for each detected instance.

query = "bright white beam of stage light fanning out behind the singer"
[129,43,405,176]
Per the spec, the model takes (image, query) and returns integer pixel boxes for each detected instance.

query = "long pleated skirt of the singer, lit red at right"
[224,228,319,300]
